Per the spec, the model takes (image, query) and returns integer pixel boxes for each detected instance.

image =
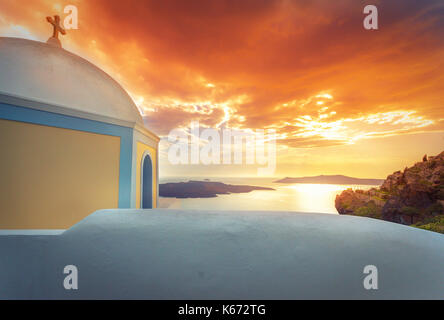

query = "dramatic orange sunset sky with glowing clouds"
[0,0,444,178]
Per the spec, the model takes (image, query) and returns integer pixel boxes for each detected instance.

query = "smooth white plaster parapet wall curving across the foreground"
[0,209,444,299]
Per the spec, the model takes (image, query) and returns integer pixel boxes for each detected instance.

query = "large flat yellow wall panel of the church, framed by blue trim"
[0,120,120,229]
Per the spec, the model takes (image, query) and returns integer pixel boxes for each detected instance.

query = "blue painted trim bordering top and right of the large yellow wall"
[0,103,133,208]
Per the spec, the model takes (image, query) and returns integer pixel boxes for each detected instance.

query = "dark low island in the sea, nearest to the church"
[159,181,274,198]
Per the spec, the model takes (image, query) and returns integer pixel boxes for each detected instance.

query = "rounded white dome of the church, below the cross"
[0,37,143,123]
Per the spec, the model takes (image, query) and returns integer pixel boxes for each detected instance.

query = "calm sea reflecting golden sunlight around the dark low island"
[159,178,375,214]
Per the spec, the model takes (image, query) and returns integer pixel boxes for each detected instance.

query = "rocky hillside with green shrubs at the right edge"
[335,151,444,233]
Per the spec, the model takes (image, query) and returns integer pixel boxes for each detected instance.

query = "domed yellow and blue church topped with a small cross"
[0,17,159,229]
